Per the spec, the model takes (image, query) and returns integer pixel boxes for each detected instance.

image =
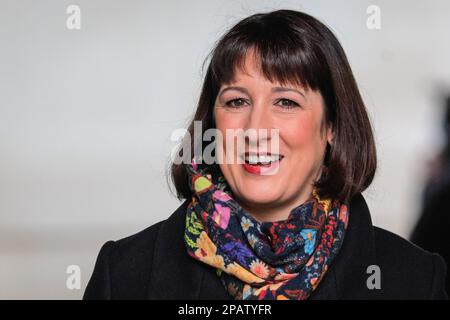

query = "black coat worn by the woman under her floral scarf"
[84,194,448,299]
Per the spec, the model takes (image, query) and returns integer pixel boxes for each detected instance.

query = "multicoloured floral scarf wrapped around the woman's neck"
[184,160,349,300]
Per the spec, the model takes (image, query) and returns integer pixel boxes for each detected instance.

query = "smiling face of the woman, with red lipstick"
[214,53,332,221]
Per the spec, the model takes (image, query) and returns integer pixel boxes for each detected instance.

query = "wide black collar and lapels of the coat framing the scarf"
[148,193,377,300]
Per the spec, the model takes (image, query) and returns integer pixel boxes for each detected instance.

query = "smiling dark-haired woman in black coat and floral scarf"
[84,10,447,300]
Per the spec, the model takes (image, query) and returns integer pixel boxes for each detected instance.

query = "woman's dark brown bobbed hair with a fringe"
[170,10,377,201]
